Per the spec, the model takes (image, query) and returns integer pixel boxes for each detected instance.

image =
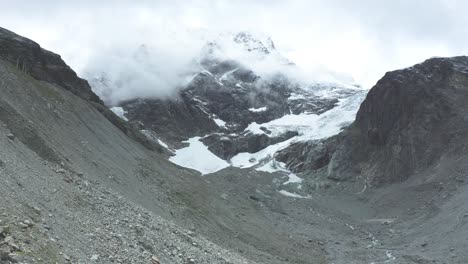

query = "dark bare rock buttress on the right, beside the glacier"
[328,57,468,186]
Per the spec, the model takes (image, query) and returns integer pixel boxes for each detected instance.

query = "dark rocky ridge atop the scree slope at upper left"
[0,28,102,104]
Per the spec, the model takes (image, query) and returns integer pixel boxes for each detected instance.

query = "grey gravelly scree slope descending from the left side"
[0,27,330,263]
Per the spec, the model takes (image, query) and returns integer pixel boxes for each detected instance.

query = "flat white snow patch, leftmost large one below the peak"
[169,137,229,175]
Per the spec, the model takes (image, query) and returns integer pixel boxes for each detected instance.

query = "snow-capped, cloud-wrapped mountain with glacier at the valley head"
[88,32,365,194]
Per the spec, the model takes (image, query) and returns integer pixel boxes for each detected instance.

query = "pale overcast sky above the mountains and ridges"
[0,0,468,88]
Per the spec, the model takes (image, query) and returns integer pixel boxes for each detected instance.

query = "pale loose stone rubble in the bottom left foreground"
[0,169,252,264]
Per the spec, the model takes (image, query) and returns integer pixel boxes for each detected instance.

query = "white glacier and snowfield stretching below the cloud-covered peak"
[169,91,363,177]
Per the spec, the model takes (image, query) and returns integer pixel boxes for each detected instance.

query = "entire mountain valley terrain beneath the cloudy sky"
[0,24,468,264]
